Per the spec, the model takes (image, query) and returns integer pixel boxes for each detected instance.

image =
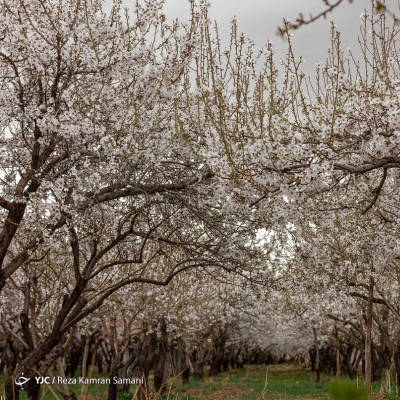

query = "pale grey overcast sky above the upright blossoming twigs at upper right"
[165,0,398,74]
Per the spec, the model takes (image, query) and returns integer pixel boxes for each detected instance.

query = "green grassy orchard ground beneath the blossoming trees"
[0,364,400,400]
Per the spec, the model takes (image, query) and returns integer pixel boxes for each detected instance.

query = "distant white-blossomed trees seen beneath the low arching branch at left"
[0,264,280,399]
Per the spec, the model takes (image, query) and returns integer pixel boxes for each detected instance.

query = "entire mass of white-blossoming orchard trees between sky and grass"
[0,0,400,399]
